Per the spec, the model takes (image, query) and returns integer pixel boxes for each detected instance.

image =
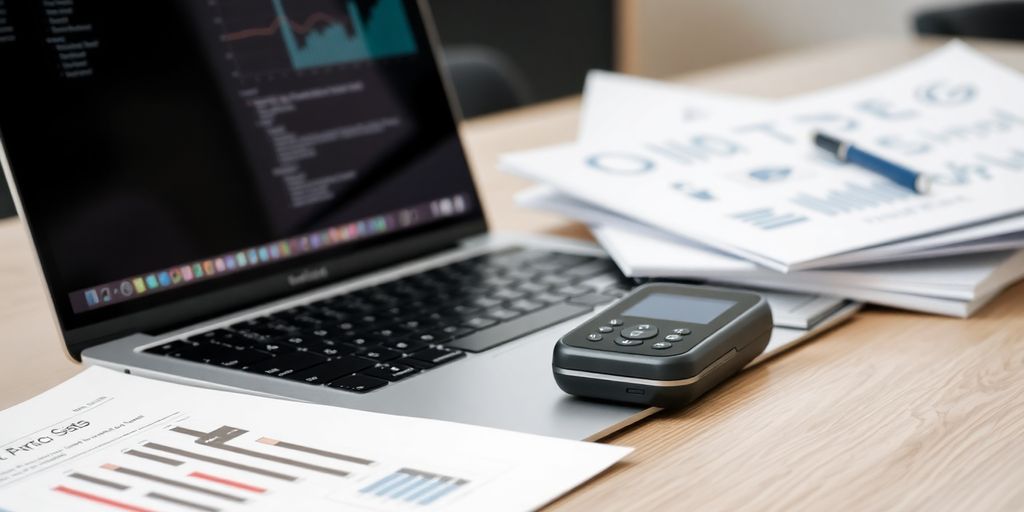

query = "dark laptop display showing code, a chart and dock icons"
[0,0,481,339]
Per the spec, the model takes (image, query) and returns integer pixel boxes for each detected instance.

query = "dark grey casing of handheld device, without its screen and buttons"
[552,284,773,407]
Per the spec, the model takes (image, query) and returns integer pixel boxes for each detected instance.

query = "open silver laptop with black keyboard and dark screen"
[0,0,653,439]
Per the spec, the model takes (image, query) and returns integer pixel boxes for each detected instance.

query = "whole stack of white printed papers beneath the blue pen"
[503,42,1024,316]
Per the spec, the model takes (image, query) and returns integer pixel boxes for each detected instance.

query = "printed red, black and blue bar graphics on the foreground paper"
[27,415,495,512]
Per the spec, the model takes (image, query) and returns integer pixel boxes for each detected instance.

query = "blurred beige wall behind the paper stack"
[618,0,978,77]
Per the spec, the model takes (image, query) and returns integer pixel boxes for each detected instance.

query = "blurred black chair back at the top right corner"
[914,2,1024,41]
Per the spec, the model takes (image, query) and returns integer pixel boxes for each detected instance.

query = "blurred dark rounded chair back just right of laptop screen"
[444,45,530,118]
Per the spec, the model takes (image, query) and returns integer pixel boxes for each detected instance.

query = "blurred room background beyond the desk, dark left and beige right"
[0,0,1024,217]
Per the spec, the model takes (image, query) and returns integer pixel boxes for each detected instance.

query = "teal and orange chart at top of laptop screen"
[215,0,418,76]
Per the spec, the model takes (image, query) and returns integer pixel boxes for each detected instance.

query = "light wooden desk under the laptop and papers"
[0,40,1024,510]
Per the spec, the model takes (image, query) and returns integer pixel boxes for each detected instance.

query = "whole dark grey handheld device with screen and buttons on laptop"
[552,283,772,407]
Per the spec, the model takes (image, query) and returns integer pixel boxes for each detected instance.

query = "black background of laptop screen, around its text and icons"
[0,0,479,329]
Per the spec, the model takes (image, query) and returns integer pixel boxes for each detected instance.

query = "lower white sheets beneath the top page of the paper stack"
[518,187,1024,316]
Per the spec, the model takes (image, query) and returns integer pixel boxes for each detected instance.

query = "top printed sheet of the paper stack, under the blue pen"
[503,43,1024,271]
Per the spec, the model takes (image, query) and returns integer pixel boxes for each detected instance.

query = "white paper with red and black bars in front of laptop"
[0,368,630,512]
